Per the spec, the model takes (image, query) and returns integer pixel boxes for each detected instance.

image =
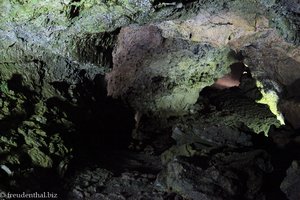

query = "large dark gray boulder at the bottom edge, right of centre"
[156,149,272,200]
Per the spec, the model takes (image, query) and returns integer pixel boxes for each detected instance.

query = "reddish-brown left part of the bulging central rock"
[106,25,163,97]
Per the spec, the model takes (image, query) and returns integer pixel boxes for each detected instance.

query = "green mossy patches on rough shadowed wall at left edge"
[0,77,71,168]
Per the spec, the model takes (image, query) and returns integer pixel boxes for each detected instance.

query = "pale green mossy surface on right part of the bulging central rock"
[150,48,236,115]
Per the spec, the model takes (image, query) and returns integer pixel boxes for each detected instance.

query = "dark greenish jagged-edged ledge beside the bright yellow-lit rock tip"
[175,88,280,138]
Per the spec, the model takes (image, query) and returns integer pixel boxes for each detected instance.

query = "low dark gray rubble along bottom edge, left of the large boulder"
[67,168,183,200]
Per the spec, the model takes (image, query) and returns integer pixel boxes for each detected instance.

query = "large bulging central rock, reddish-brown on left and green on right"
[106,25,237,115]
